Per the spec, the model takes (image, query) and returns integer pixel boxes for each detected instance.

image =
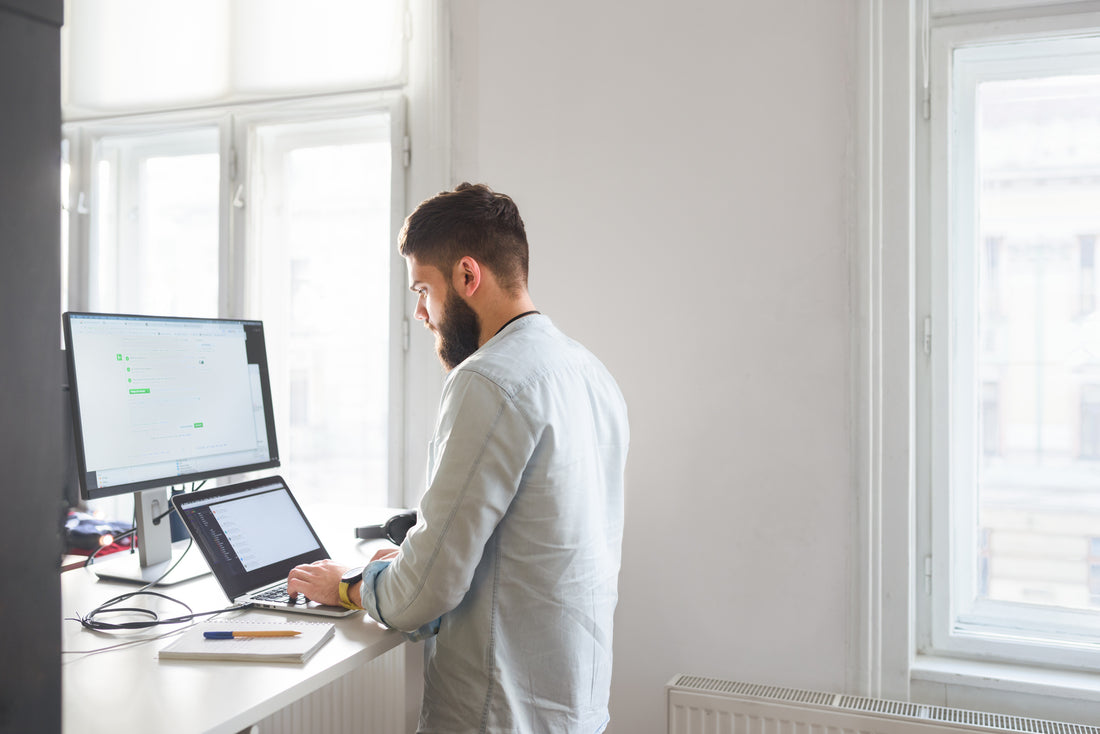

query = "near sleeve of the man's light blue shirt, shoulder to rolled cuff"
[363,369,536,632]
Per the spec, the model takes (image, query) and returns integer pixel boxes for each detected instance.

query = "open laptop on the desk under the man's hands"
[172,476,355,616]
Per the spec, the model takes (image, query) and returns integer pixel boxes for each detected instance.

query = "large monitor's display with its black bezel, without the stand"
[64,313,279,500]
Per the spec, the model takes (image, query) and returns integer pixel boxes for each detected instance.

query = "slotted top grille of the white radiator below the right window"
[669,676,1100,734]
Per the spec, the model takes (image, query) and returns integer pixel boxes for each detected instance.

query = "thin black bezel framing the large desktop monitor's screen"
[62,311,279,500]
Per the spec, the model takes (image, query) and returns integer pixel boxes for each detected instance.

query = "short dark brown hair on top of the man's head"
[397,183,528,293]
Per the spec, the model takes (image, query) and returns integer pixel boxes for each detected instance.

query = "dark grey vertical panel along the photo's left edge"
[0,0,65,733]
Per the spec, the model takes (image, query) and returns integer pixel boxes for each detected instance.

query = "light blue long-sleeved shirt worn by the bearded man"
[362,315,629,734]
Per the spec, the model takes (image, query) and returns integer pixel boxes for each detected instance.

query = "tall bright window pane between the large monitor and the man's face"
[251,114,395,504]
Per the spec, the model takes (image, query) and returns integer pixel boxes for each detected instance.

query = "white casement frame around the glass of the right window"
[912,12,1100,670]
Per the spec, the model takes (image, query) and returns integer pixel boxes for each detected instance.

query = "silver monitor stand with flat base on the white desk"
[91,487,210,587]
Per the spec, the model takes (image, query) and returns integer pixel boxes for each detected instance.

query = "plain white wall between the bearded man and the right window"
[451,0,857,733]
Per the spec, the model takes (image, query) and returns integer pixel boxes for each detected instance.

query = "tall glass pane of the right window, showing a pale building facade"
[974,76,1100,610]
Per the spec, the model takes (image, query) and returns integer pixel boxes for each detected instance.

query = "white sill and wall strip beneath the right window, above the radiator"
[910,655,1100,726]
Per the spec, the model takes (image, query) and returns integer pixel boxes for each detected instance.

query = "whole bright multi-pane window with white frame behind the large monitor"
[62,0,407,505]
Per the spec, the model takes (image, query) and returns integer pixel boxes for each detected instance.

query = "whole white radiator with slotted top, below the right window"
[667,676,1100,734]
